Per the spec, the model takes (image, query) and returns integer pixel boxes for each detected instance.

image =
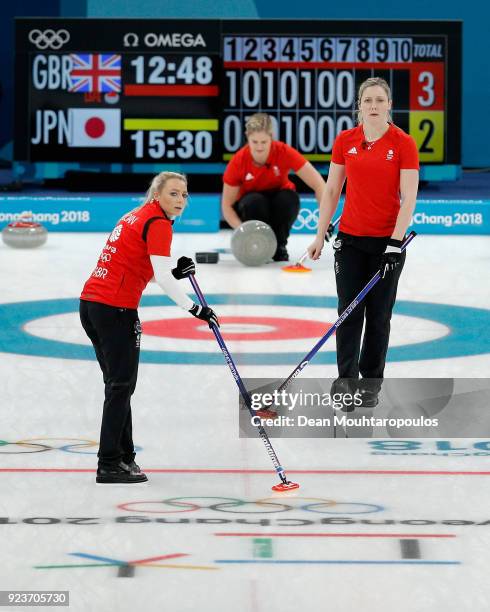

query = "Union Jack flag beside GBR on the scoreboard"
[68,53,121,93]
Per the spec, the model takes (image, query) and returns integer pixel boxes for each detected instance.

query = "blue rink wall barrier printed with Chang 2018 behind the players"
[0,194,490,234]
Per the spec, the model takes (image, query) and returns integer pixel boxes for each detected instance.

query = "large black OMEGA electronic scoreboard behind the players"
[14,19,461,172]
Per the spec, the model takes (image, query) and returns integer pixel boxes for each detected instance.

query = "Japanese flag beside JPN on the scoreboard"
[68,108,121,147]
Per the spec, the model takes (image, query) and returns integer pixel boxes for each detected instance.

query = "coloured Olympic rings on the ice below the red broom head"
[117,497,384,515]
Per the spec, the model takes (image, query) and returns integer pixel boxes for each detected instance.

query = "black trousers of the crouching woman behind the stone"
[235,189,299,247]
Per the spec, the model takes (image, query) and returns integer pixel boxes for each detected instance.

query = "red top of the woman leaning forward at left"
[80,200,172,309]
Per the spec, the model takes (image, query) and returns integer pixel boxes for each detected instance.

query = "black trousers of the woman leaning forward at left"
[80,300,141,469]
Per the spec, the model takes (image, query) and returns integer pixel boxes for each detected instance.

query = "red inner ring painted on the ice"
[143,317,331,340]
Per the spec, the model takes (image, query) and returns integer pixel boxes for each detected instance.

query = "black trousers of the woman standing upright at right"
[334,232,406,379]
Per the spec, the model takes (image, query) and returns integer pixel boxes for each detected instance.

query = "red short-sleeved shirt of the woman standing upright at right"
[332,124,419,237]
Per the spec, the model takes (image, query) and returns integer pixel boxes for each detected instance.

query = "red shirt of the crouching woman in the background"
[223,140,306,199]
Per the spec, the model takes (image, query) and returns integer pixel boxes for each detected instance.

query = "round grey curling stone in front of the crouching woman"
[231,220,277,266]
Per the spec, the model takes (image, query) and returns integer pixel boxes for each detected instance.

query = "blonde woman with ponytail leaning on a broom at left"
[80,172,218,484]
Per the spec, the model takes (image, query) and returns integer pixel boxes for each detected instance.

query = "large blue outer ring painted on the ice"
[0,293,490,366]
